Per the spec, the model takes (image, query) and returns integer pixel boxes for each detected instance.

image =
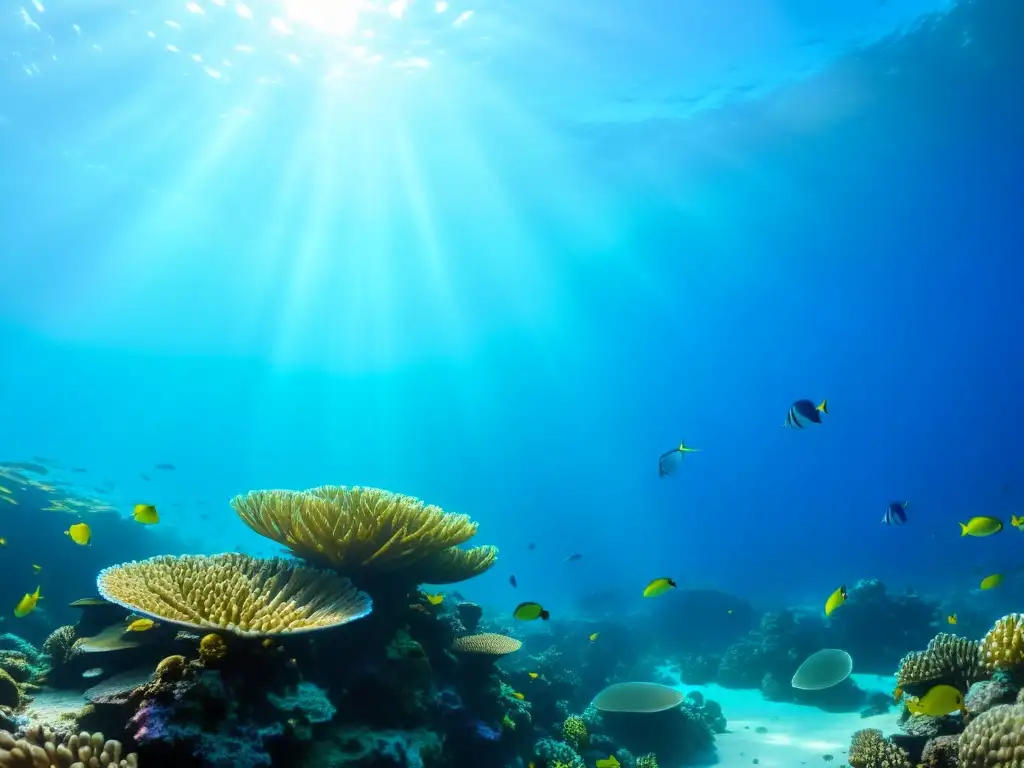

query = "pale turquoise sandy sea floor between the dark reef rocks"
[683,675,896,768]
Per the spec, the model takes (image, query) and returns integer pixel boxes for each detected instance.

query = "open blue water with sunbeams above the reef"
[0,0,1024,615]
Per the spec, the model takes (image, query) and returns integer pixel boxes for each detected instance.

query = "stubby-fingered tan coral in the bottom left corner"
[0,726,138,768]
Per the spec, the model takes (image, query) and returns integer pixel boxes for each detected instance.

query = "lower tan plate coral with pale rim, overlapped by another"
[96,553,373,637]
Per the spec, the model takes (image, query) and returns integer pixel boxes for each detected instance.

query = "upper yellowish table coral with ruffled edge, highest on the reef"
[231,485,498,584]
